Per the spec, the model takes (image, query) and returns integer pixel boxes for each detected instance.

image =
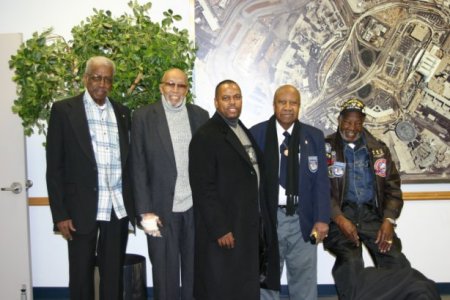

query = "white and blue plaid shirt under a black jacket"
[83,91,127,221]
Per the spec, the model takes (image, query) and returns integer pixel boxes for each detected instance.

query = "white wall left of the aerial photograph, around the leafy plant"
[0,0,193,287]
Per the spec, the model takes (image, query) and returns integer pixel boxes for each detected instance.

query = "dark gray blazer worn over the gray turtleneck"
[131,100,209,224]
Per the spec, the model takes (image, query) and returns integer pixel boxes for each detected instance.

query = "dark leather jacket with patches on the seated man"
[325,129,403,220]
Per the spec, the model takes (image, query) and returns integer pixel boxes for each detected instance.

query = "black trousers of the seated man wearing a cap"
[324,204,410,299]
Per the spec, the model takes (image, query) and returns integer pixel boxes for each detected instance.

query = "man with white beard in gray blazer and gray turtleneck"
[131,68,209,300]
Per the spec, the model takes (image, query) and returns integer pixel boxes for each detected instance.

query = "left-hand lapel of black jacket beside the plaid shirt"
[68,94,95,163]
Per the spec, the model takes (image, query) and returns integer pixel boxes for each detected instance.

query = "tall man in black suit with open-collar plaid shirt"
[47,56,134,300]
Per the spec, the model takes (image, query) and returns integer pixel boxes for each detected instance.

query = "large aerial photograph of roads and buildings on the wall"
[195,0,450,183]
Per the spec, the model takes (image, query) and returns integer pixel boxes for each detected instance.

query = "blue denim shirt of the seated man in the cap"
[344,136,375,204]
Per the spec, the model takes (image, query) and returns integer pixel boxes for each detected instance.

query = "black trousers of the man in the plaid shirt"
[68,212,129,300]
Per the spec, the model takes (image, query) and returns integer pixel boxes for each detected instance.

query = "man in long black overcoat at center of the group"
[189,80,279,300]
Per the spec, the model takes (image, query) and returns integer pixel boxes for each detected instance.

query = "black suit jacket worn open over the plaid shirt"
[46,94,135,233]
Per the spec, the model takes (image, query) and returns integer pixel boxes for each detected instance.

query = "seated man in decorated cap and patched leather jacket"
[324,99,410,299]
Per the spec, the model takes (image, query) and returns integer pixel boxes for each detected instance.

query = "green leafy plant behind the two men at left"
[9,1,196,136]
